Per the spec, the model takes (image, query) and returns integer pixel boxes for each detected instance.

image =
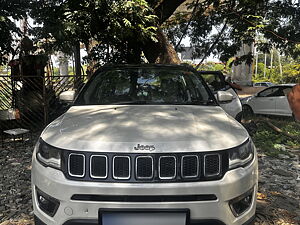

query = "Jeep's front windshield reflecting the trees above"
[75,68,215,105]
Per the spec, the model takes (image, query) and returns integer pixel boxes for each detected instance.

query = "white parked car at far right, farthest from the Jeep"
[242,84,295,116]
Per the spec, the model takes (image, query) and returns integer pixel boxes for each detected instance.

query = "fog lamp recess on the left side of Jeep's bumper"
[36,188,59,217]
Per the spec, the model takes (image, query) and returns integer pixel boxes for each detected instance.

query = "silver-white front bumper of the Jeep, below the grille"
[32,152,258,225]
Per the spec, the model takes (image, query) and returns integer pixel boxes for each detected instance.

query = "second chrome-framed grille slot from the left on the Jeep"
[90,155,108,179]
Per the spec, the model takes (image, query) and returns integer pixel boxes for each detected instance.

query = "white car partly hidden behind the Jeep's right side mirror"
[199,71,242,122]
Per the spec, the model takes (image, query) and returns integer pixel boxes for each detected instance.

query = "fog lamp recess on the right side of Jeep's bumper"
[229,188,253,217]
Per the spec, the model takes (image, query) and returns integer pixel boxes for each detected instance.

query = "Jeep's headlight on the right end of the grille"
[229,139,255,169]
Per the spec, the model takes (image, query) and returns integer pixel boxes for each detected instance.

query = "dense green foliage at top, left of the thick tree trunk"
[31,0,157,62]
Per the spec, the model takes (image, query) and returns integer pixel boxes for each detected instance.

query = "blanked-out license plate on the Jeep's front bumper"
[99,210,189,225]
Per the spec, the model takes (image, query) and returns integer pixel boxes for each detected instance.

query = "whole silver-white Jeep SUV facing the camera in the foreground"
[32,65,258,225]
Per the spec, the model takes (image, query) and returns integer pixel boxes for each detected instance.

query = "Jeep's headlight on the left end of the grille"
[36,139,62,169]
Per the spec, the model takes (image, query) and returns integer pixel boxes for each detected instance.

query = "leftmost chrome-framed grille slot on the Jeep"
[68,153,85,177]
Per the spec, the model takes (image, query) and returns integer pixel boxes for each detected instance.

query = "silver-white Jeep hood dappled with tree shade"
[41,105,248,153]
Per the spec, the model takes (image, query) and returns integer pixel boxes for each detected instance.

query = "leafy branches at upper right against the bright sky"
[168,0,300,63]
